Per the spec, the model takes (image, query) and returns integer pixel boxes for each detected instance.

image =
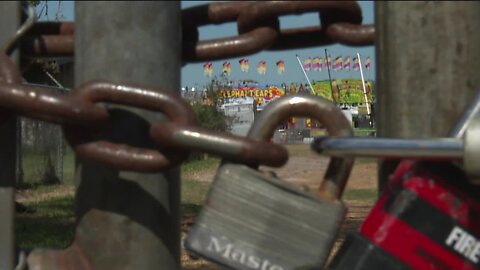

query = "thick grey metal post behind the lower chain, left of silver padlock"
[29,1,182,269]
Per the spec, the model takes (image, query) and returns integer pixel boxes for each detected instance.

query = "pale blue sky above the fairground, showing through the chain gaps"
[37,1,375,89]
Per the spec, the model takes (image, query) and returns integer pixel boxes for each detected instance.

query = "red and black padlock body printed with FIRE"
[334,161,480,270]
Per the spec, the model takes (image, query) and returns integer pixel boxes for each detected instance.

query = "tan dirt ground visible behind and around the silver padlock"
[182,156,377,270]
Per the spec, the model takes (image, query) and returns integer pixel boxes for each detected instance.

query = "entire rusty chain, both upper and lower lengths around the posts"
[0,1,374,172]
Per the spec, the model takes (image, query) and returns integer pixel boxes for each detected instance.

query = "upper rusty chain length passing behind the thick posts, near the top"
[21,1,374,63]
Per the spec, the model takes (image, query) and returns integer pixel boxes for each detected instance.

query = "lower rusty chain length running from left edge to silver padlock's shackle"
[0,54,288,172]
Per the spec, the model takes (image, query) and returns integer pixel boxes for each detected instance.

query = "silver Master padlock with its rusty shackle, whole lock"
[185,95,353,270]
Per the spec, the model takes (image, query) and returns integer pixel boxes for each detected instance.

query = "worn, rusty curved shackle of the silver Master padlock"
[248,94,354,200]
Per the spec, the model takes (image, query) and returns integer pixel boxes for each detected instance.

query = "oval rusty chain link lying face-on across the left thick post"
[64,81,196,172]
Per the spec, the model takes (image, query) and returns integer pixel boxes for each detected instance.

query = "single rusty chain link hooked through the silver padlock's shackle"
[150,122,288,167]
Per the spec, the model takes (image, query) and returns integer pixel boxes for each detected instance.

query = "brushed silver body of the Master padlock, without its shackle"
[185,164,346,270]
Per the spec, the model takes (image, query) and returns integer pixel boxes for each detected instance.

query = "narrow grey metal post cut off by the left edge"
[0,1,21,270]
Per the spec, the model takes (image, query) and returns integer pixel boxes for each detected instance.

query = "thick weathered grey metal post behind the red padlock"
[375,1,480,190]
